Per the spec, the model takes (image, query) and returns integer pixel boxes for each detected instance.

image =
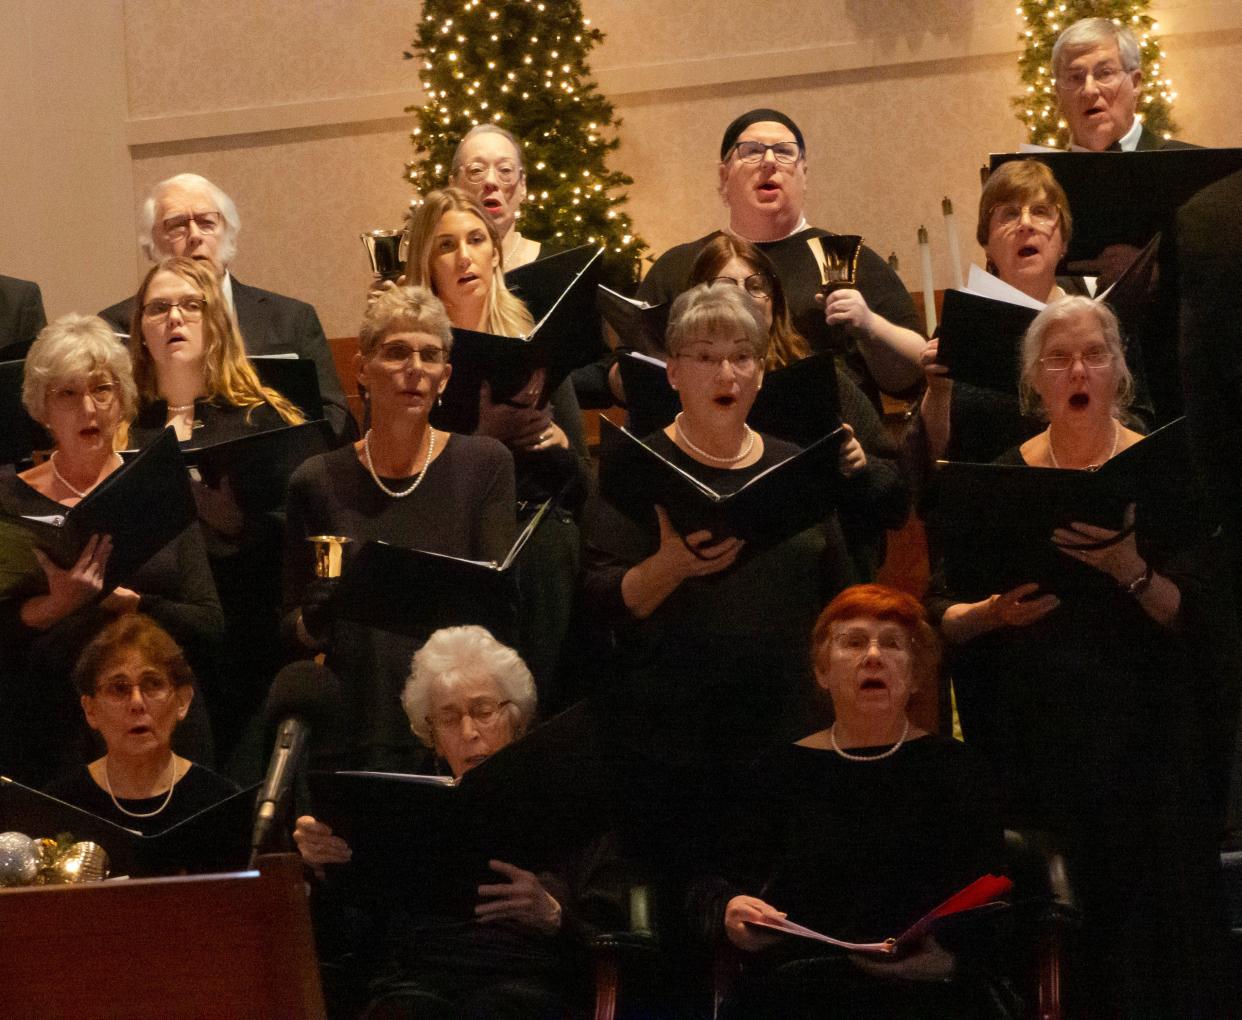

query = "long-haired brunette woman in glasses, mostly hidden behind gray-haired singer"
[688,234,909,579]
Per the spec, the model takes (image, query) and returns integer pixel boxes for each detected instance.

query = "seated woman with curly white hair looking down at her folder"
[293,626,606,1020]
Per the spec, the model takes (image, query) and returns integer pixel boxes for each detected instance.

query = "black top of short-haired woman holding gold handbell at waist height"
[284,435,517,772]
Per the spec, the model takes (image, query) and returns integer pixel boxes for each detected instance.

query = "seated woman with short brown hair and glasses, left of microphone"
[47,614,237,835]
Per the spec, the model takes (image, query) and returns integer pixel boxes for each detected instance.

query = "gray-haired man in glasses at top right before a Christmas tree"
[1052,17,1194,153]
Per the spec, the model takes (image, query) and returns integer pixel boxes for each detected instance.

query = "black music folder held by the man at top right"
[990,148,1242,262]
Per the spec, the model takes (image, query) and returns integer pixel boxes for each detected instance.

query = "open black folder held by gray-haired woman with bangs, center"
[600,419,847,547]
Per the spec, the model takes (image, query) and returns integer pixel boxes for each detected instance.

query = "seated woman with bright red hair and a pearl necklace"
[694,584,1004,1018]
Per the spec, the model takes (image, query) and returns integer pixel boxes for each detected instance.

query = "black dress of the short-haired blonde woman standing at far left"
[0,475,225,788]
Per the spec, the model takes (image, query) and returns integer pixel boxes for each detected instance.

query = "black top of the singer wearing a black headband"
[638,227,923,403]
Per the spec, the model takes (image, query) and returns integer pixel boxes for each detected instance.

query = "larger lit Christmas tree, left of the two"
[405,0,647,273]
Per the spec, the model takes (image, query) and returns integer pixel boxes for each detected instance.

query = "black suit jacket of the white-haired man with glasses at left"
[99,276,358,440]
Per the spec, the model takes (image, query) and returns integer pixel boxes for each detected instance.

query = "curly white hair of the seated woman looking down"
[401,626,537,748]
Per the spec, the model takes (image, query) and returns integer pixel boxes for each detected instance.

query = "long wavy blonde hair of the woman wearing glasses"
[129,256,306,425]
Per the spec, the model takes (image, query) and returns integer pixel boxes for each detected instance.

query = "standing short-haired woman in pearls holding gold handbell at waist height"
[284,287,515,772]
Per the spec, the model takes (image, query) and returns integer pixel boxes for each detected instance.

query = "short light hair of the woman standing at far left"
[21,313,138,424]
